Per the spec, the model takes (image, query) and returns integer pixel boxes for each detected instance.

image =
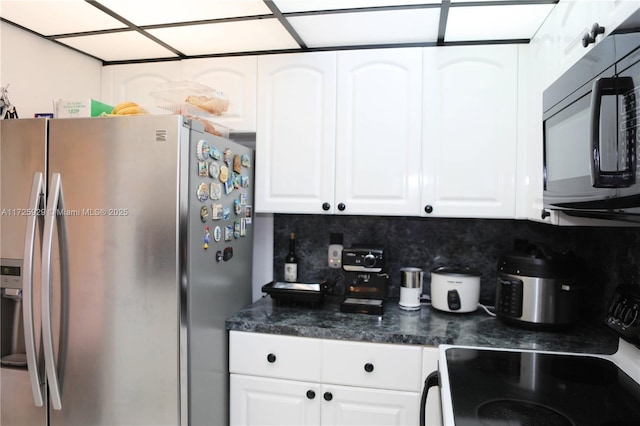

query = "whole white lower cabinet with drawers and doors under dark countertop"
[229,331,441,426]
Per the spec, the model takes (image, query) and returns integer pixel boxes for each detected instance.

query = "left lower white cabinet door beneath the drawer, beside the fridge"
[229,374,321,426]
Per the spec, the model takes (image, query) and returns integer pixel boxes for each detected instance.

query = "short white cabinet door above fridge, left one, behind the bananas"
[102,61,182,114]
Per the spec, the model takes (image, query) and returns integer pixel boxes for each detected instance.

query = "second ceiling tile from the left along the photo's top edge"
[98,0,271,26]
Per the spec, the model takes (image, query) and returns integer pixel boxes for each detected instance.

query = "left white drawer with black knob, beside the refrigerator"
[229,331,322,381]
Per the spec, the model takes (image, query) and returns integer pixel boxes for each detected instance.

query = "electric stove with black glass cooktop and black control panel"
[432,288,640,426]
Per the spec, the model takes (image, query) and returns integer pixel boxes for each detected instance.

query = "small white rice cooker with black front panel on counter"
[431,266,480,313]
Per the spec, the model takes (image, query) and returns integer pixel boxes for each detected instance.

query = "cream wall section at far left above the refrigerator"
[0,22,102,118]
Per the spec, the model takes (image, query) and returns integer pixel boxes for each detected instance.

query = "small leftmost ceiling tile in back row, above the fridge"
[57,31,177,61]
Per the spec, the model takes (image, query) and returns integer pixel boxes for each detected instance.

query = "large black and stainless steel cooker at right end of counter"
[495,245,583,330]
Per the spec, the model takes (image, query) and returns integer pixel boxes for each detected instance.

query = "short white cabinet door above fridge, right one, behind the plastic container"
[182,56,258,132]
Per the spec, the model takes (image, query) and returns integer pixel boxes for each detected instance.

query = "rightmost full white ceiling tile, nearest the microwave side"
[444,4,554,42]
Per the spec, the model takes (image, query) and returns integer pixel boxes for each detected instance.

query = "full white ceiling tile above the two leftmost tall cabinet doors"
[287,8,440,48]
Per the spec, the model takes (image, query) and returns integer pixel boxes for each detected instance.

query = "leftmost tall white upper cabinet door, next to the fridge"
[255,52,336,213]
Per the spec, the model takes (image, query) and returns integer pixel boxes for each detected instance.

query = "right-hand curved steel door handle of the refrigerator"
[41,173,66,410]
